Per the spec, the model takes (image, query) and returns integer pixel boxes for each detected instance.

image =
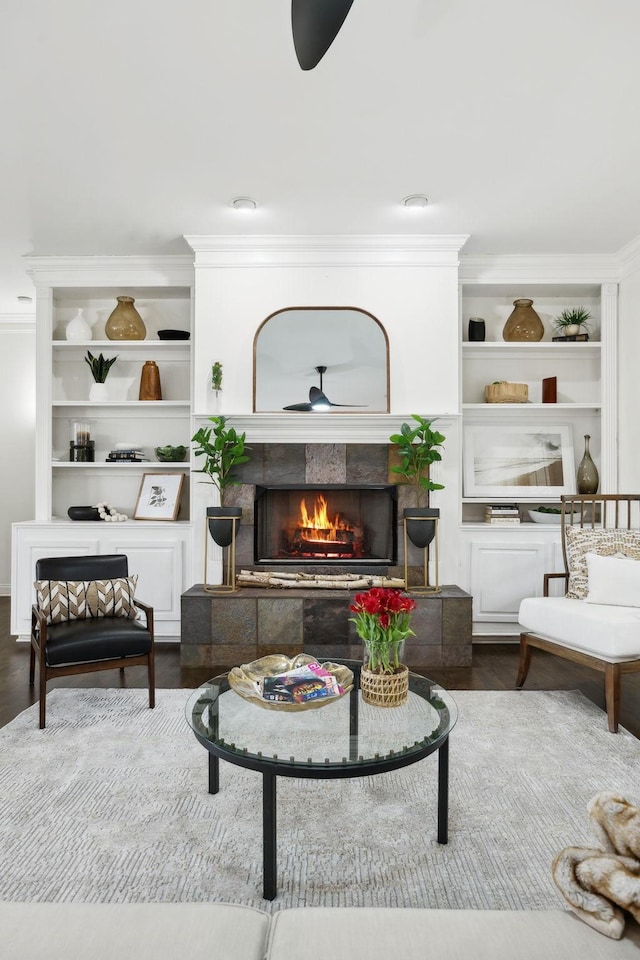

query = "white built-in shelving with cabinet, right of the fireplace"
[460,272,617,635]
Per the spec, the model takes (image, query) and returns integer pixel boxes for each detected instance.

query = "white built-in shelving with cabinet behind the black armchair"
[12,257,193,637]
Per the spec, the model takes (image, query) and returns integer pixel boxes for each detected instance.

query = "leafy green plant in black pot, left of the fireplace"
[191,415,250,547]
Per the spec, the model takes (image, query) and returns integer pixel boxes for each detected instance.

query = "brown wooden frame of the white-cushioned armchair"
[516,494,640,733]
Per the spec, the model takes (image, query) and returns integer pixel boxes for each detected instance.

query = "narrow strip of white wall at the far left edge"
[0,317,36,596]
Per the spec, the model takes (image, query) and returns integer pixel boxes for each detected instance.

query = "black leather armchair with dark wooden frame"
[29,554,155,730]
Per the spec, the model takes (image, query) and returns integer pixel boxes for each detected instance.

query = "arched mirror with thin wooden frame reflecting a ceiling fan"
[253,307,389,413]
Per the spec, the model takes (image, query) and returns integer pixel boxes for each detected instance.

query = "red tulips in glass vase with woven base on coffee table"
[349,587,416,707]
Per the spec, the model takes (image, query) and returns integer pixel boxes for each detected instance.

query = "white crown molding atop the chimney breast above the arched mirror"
[184,234,468,270]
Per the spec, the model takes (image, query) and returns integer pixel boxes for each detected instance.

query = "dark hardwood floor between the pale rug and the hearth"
[0,597,640,738]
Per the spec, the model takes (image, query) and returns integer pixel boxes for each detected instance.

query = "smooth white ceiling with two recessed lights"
[0,0,640,315]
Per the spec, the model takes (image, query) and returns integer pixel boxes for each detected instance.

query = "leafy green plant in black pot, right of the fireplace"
[389,413,446,548]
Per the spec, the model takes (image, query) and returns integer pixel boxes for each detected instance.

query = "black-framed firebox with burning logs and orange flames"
[254,484,398,566]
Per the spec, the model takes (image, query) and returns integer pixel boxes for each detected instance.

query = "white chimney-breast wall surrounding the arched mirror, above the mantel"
[187,236,466,415]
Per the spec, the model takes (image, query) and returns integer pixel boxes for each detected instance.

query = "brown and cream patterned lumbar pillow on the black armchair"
[34,574,138,623]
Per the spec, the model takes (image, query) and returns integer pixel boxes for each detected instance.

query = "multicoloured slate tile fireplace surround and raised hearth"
[180,443,471,668]
